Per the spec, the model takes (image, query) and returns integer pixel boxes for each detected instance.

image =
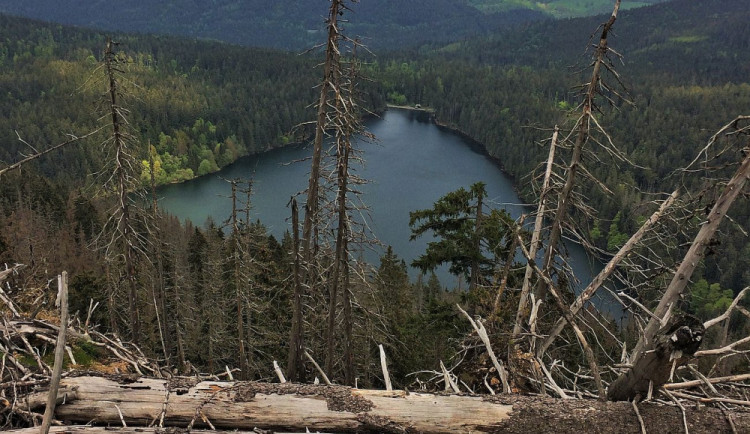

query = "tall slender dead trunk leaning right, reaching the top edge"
[535,0,620,299]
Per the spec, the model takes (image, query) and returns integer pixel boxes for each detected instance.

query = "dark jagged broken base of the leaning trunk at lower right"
[607,315,706,401]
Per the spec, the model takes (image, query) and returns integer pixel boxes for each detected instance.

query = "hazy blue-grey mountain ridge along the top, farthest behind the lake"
[0,0,663,50]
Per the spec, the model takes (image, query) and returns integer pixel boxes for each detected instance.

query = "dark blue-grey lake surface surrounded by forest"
[159,109,616,316]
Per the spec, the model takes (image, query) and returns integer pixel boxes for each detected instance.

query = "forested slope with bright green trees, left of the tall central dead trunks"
[0,16,382,183]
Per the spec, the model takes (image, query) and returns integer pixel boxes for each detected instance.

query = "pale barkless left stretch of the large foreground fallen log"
[29,377,512,432]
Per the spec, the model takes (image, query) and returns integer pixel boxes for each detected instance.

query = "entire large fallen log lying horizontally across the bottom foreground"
[18,376,750,434]
